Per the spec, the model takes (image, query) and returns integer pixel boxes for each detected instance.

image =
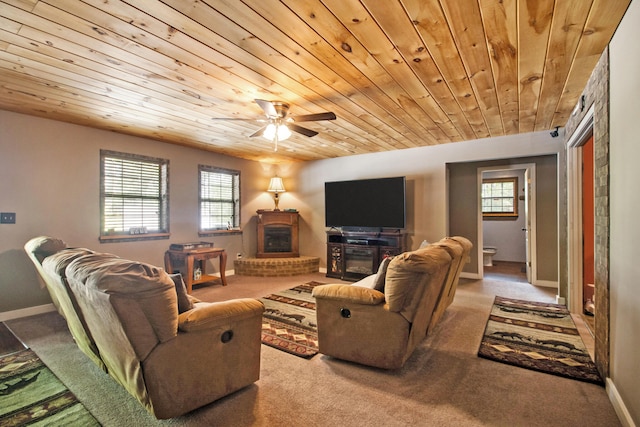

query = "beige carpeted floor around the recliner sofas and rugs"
[2,274,620,427]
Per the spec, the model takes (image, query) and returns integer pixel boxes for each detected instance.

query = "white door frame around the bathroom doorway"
[476,163,537,284]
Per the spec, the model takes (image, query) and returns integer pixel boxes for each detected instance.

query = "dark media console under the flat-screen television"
[327,230,405,281]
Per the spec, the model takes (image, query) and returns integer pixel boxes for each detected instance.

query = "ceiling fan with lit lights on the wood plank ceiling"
[216,99,336,151]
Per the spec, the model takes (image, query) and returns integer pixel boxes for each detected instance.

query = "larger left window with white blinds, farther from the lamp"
[100,150,169,241]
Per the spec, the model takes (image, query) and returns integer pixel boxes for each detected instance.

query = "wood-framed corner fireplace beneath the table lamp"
[256,210,300,258]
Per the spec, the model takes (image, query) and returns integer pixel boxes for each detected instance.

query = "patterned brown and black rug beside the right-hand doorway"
[478,296,603,385]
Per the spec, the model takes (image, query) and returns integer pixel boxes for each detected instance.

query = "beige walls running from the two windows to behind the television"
[0,111,561,313]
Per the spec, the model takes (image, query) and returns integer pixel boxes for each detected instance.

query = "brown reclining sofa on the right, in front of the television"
[312,238,471,369]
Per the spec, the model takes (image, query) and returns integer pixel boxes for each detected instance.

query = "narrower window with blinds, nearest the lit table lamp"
[198,165,240,234]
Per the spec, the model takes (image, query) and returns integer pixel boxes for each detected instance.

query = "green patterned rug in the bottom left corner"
[0,349,100,426]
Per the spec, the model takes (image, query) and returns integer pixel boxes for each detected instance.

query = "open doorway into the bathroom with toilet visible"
[478,163,536,283]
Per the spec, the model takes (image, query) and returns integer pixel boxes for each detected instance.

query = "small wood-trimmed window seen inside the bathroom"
[482,177,518,218]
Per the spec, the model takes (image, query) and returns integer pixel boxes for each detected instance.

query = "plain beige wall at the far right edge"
[609,1,640,425]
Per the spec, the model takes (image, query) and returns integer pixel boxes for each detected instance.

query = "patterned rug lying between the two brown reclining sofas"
[260,281,324,358]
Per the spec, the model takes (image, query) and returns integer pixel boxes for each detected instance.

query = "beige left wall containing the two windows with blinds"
[0,111,284,313]
